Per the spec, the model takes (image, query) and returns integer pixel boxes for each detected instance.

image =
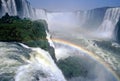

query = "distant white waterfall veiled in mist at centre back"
[47,12,79,31]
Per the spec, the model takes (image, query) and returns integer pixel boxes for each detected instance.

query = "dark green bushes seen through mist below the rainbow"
[57,57,88,79]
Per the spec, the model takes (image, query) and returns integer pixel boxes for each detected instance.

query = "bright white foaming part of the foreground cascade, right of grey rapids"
[15,48,65,81]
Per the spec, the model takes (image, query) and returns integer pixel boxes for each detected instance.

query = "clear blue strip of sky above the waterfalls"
[28,0,120,11]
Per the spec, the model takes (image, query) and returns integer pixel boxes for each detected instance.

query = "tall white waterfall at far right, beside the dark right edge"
[98,8,120,39]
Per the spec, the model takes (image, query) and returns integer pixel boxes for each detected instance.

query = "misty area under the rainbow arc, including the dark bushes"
[55,43,117,81]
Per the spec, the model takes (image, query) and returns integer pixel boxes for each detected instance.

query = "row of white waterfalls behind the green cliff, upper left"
[0,0,47,20]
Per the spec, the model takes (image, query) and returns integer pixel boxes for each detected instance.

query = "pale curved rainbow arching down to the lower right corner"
[51,38,120,81]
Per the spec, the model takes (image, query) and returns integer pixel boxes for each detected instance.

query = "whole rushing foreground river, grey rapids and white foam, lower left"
[0,42,66,81]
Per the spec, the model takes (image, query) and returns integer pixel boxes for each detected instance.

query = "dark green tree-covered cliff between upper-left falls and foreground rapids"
[0,14,49,50]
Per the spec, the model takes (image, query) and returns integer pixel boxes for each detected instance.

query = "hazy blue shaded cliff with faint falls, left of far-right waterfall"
[77,7,108,30]
